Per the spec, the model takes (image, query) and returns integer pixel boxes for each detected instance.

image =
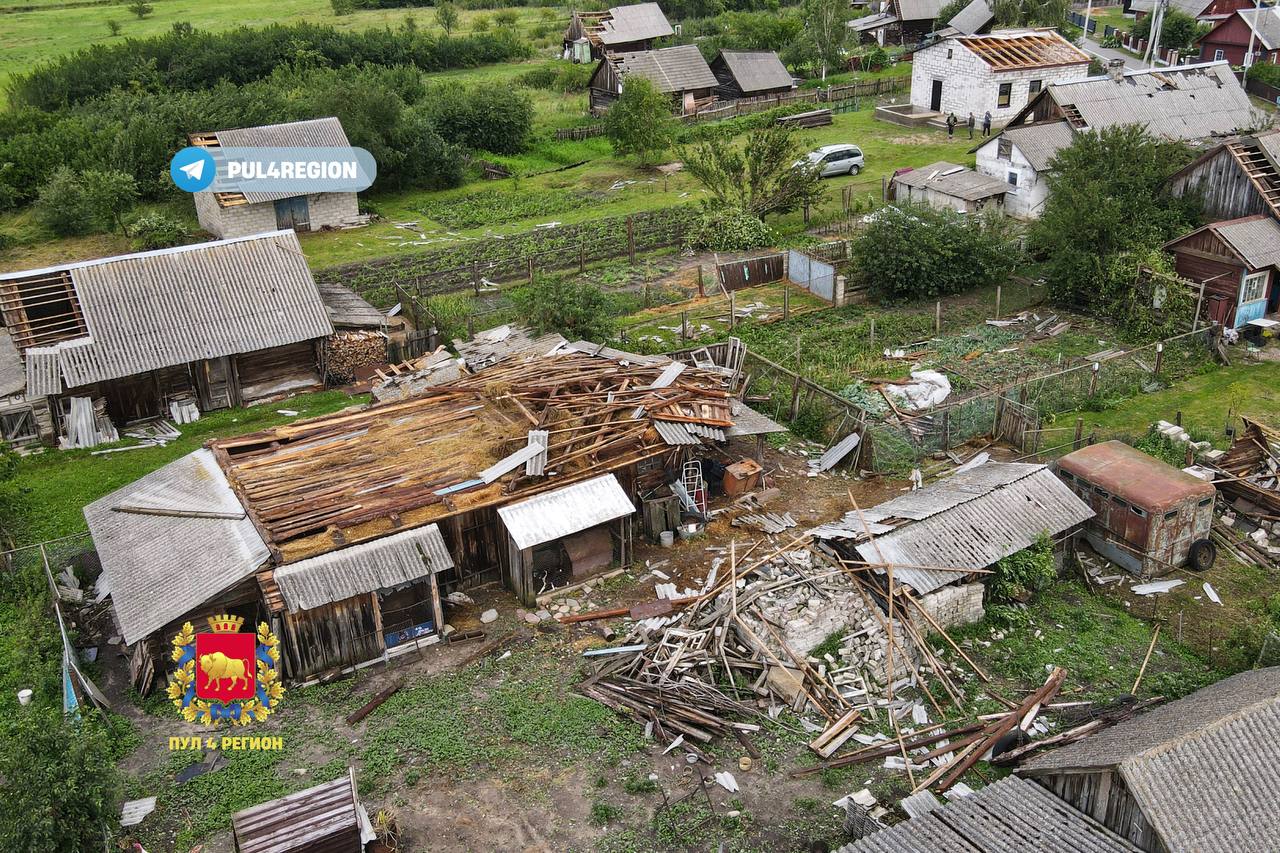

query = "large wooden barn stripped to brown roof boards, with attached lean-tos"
[84,343,781,690]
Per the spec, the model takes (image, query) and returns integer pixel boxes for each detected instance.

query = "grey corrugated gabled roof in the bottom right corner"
[1019,666,1280,853]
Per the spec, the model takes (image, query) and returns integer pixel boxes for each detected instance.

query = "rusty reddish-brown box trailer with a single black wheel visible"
[1055,441,1216,578]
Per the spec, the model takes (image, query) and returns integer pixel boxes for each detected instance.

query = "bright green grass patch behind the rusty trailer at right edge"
[1064,361,1280,447]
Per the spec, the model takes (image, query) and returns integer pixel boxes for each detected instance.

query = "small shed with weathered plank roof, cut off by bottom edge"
[232,770,374,853]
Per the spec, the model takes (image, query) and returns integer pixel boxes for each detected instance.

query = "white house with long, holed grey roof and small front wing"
[973,60,1270,219]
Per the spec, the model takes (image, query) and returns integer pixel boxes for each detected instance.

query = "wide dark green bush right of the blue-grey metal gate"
[852,206,1016,302]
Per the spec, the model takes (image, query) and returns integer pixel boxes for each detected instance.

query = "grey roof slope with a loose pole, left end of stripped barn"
[84,450,268,644]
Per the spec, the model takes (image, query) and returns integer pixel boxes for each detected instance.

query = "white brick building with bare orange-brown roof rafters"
[911,29,1089,128]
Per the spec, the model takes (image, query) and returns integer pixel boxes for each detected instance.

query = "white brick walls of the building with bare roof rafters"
[911,38,1089,122]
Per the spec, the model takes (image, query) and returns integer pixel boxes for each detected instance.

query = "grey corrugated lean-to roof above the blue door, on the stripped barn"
[275,524,453,613]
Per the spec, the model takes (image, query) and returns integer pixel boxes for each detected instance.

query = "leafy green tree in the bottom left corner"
[0,702,120,853]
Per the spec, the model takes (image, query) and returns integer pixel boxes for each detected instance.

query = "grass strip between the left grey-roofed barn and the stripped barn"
[0,391,367,544]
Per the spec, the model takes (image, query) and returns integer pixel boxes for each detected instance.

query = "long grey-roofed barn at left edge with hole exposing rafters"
[0,231,385,447]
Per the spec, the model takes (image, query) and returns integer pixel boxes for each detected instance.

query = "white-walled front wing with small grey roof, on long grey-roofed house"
[977,122,1075,219]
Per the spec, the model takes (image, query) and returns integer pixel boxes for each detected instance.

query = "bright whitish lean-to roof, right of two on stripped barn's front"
[498,474,636,551]
